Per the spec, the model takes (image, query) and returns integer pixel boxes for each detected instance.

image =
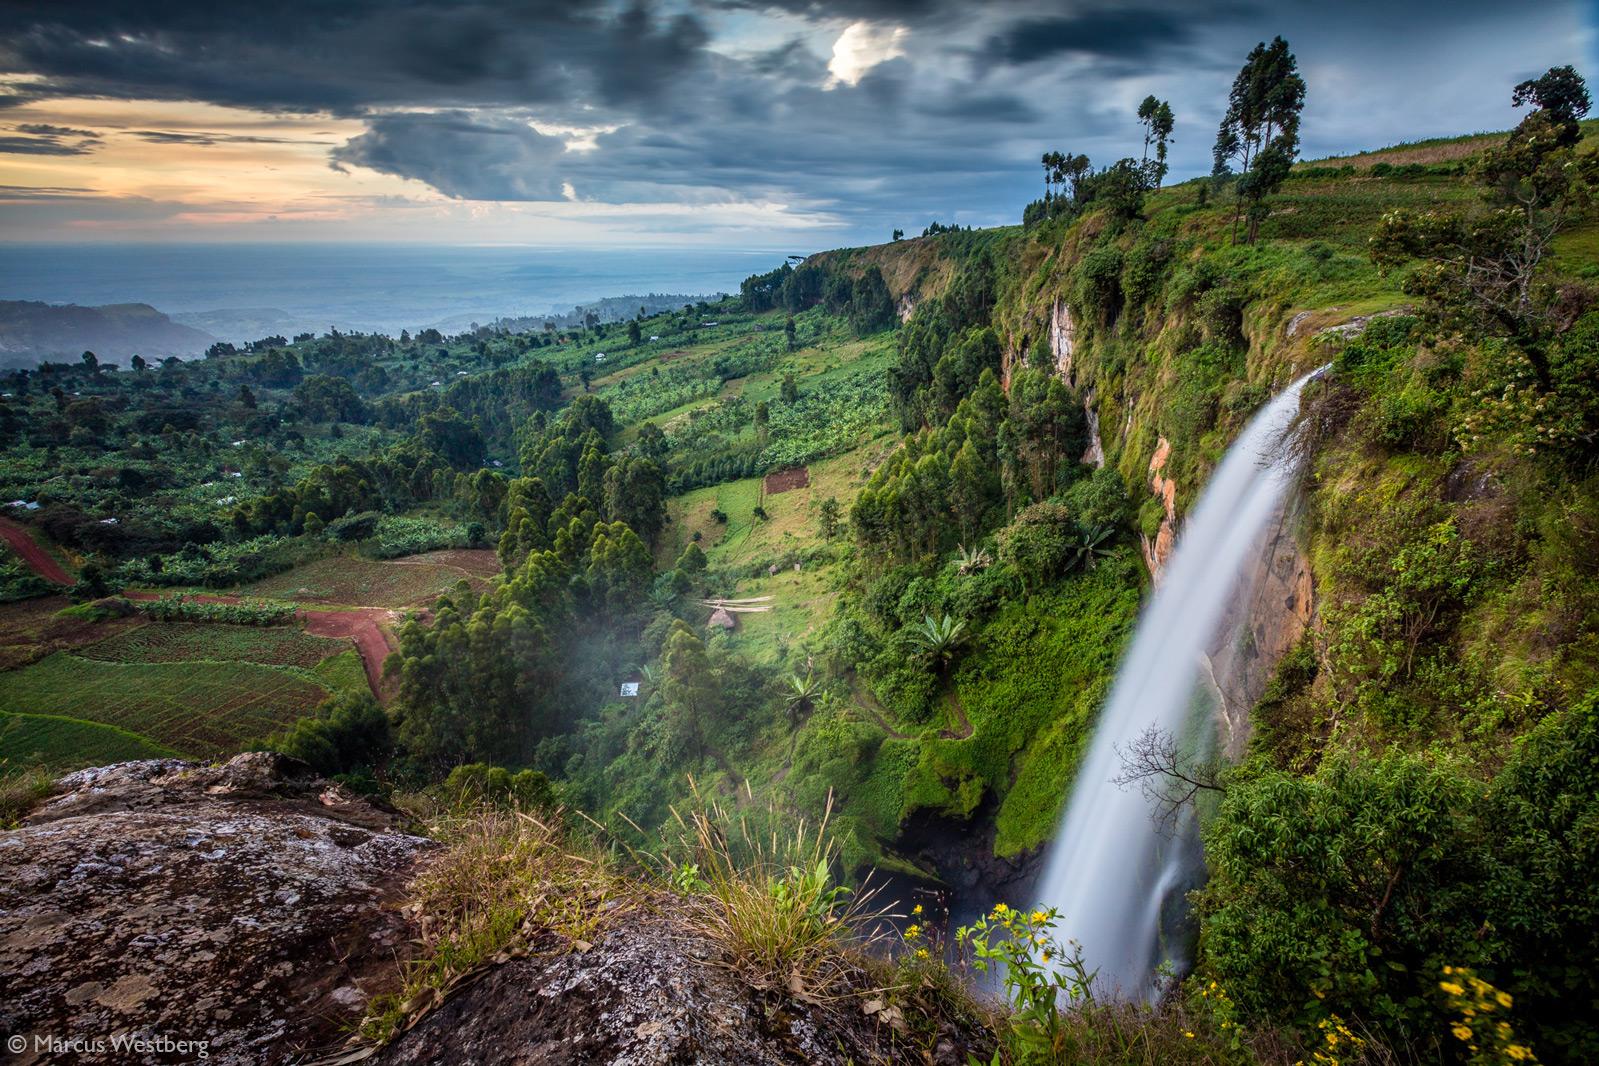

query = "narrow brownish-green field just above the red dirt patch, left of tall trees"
[240,551,497,607]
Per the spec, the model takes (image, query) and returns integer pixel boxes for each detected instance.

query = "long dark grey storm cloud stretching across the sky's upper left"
[0,0,707,113]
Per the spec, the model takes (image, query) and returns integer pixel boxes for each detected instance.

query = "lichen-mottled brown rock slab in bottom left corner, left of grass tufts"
[0,753,432,1066]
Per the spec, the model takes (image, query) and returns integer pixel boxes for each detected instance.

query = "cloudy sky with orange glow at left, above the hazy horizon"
[0,0,1599,249]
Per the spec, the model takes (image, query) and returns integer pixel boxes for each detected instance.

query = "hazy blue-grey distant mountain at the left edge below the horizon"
[0,300,216,366]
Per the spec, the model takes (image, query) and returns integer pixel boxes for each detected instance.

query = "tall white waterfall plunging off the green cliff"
[1039,368,1326,999]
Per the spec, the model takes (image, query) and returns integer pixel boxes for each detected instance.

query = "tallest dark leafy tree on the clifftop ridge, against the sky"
[1214,37,1305,243]
